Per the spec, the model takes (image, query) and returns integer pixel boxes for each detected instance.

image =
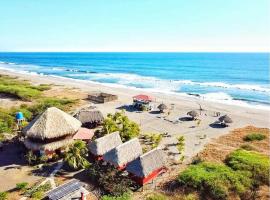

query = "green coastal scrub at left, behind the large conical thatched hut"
[0,75,76,138]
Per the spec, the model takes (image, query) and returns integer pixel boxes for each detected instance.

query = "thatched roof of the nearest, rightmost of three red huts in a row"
[126,149,166,178]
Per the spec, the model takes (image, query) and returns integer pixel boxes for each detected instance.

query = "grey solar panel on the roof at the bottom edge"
[47,180,82,200]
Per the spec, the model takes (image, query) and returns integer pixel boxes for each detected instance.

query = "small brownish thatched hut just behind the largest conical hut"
[74,108,104,128]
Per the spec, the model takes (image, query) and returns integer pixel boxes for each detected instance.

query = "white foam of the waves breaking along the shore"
[0,63,270,109]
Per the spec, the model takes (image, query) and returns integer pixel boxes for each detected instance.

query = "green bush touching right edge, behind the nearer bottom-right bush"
[225,149,270,184]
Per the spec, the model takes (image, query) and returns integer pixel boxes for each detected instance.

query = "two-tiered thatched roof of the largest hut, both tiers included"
[23,107,81,151]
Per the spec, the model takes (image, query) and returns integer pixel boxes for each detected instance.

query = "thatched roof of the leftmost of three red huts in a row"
[89,132,122,156]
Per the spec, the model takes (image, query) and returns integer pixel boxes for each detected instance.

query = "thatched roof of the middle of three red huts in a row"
[103,138,142,167]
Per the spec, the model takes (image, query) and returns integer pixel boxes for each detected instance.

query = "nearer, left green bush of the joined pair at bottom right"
[178,162,251,199]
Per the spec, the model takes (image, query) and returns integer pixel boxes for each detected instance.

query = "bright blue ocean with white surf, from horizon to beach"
[0,53,270,106]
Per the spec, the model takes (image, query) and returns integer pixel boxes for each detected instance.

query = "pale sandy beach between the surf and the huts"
[0,70,270,161]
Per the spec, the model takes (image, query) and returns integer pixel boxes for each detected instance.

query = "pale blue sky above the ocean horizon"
[0,0,270,52]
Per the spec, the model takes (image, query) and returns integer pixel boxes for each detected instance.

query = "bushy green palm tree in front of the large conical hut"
[64,140,90,170]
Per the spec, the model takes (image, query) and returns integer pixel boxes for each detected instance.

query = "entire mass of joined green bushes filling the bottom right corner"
[178,149,270,199]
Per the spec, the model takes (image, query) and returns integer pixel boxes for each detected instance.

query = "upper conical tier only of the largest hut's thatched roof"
[23,107,81,140]
